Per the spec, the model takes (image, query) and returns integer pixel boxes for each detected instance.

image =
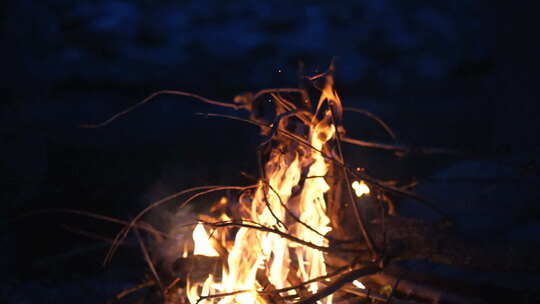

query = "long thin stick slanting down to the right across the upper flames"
[198,113,450,219]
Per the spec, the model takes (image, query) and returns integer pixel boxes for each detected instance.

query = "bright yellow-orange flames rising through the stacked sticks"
[184,76,369,304]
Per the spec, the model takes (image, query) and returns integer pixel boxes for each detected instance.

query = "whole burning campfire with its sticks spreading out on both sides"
[80,66,532,304]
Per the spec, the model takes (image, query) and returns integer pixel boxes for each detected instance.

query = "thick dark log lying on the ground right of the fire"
[370,217,540,273]
